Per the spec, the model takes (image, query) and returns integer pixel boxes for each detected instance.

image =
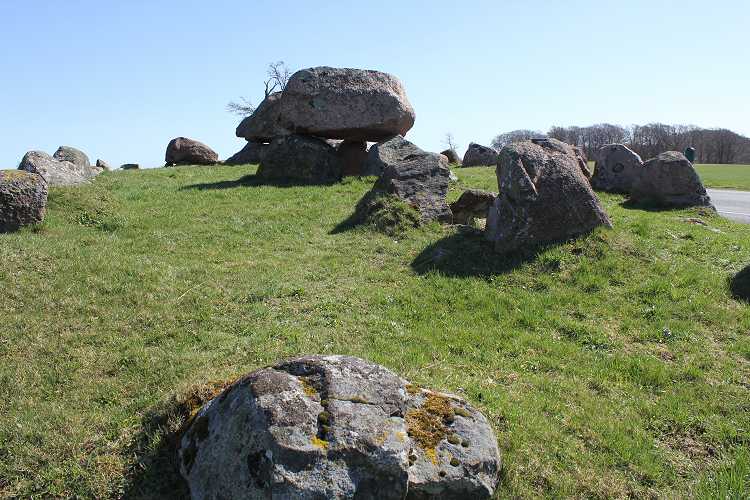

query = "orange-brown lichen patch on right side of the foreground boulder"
[406,392,454,464]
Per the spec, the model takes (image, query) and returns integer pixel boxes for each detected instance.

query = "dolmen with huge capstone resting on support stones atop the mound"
[235,66,415,182]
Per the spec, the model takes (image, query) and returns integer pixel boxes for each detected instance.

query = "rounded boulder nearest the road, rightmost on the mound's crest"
[630,151,712,208]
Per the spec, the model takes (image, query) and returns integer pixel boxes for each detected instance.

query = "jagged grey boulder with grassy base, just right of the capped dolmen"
[365,135,453,223]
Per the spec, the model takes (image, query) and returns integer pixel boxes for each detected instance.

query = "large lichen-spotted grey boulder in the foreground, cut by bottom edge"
[178,356,501,499]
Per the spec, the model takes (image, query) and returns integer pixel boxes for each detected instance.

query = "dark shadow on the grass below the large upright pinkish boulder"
[411,226,554,278]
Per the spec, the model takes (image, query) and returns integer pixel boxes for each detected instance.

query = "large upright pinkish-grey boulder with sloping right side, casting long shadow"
[485,139,611,253]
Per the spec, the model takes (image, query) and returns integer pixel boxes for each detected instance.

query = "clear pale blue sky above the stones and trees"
[0,0,750,168]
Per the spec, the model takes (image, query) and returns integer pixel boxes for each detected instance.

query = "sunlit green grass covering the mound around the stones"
[0,167,750,498]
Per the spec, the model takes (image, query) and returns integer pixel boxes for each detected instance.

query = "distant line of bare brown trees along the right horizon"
[492,123,750,164]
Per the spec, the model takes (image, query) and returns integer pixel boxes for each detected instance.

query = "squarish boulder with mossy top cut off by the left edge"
[0,170,47,233]
